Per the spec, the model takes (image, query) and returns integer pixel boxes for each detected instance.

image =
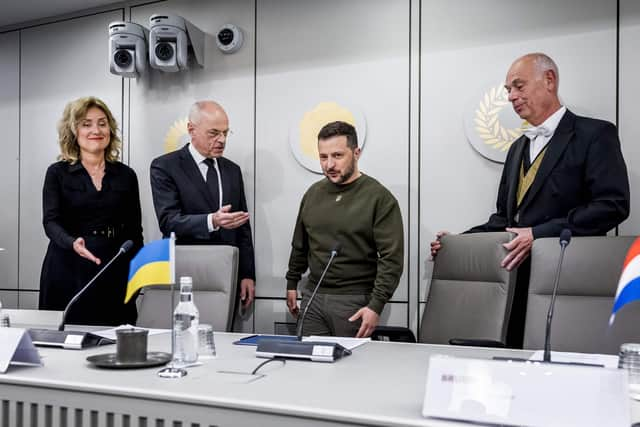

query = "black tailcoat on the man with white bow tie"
[468,110,629,238]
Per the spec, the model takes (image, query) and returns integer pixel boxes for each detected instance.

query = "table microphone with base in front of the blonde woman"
[29,240,133,349]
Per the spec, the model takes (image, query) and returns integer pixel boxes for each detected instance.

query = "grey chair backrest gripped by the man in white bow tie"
[420,232,516,344]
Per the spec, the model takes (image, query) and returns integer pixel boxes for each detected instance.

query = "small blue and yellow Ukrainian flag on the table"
[124,233,175,303]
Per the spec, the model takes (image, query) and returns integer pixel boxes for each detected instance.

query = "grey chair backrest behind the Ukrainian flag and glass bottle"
[137,245,238,331]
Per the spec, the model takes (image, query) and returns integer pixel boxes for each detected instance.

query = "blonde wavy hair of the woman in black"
[58,96,122,164]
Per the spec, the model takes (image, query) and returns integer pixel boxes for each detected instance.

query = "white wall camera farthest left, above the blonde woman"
[109,21,147,77]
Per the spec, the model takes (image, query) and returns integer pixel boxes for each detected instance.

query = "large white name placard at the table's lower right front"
[422,356,631,427]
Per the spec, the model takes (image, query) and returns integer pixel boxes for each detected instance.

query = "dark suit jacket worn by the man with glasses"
[151,144,255,280]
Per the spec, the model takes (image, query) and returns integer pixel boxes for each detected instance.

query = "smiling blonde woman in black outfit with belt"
[40,97,142,325]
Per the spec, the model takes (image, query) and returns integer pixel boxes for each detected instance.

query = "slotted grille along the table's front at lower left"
[0,384,344,427]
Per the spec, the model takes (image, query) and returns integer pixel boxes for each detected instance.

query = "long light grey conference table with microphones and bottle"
[0,310,640,427]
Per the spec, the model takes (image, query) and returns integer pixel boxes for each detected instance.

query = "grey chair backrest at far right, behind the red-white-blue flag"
[524,236,640,354]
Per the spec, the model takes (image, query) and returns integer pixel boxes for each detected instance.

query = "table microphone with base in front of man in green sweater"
[256,242,351,362]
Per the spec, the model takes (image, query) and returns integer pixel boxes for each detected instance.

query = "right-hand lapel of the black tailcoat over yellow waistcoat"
[520,110,576,214]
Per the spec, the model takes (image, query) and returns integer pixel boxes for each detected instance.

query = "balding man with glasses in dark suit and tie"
[151,101,255,309]
